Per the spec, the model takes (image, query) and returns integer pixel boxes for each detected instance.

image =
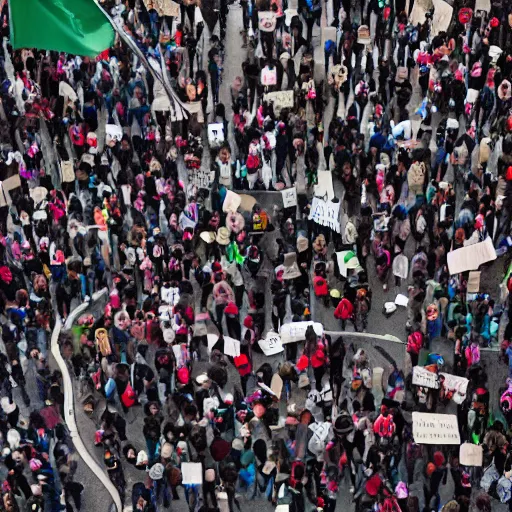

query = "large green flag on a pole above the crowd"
[9,0,114,57]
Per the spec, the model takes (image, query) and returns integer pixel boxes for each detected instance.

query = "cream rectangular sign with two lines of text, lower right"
[412,412,460,444]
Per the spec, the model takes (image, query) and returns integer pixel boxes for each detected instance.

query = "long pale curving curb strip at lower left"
[51,288,123,512]
